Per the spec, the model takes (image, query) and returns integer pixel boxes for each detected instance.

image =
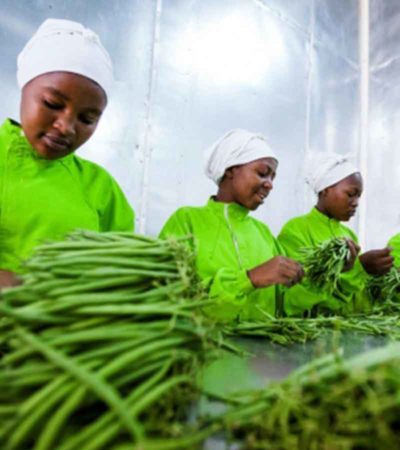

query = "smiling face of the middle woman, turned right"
[225,158,278,210]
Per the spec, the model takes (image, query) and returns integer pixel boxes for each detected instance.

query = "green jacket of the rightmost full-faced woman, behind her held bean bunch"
[278,208,367,315]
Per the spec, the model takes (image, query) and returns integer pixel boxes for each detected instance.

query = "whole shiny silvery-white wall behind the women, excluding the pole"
[0,0,382,246]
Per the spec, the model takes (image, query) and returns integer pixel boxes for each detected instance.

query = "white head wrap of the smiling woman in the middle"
[205,129,278,184]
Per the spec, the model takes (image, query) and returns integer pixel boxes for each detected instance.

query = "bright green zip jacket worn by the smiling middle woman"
[160,199,283,321]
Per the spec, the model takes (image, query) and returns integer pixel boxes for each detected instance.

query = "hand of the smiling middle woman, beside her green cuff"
[247,256,304,288]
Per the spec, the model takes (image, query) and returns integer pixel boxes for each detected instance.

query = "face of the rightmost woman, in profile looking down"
[317,173,363,222]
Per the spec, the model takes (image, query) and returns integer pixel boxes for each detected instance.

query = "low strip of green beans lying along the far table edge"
[224,312,400,346]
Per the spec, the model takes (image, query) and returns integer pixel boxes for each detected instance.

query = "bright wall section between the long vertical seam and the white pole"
[140,0,359,237]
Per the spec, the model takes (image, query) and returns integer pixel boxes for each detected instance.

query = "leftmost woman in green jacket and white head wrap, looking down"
[0,19,134,286]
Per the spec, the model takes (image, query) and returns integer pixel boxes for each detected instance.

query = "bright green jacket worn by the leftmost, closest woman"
[0,120,134,272]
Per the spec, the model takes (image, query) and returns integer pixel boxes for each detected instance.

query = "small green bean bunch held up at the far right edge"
[367,267,400,303]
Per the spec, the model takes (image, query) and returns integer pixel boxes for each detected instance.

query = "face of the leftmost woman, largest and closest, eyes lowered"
[21,72,107,159]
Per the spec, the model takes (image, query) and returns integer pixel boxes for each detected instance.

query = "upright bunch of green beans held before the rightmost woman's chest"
[300,238,350,293]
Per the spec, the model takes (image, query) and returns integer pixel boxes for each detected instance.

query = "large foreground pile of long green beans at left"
[0,231,225,450]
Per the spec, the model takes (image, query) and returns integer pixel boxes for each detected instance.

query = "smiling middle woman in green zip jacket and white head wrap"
[160,130,303,321]
